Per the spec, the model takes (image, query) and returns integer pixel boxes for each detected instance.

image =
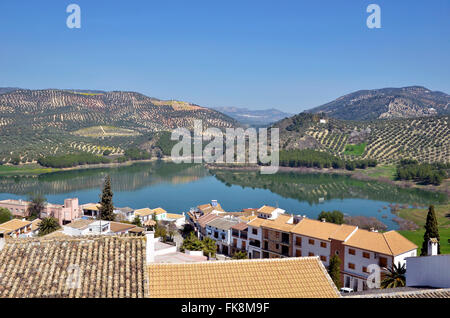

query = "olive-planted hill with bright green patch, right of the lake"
[274,113,450,164]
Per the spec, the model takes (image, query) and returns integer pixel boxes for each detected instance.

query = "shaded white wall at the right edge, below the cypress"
[406,254,450,288]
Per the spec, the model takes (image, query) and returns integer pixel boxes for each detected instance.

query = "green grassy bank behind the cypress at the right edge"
[398,204,450,254]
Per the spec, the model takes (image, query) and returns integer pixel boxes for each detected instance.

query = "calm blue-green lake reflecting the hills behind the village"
[0,162,447,229]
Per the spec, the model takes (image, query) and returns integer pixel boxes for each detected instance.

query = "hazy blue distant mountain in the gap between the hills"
[215,107,293,126]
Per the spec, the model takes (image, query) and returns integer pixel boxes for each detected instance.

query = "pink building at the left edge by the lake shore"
[0,198,82,225]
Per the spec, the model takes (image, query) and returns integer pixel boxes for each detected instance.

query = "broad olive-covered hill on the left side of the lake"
[0,88,238,163]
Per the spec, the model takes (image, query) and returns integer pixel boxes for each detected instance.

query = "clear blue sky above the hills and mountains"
[0,0,450,113]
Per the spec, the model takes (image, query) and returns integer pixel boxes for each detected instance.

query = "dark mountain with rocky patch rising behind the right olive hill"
[307,86,450,120]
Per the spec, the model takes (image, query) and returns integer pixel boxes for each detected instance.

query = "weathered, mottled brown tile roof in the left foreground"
[0,236,148,298]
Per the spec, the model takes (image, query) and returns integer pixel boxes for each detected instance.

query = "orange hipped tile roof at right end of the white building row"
[343,229,417,255]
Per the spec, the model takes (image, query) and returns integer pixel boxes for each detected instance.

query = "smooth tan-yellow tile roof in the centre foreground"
[148,257,340,298]
